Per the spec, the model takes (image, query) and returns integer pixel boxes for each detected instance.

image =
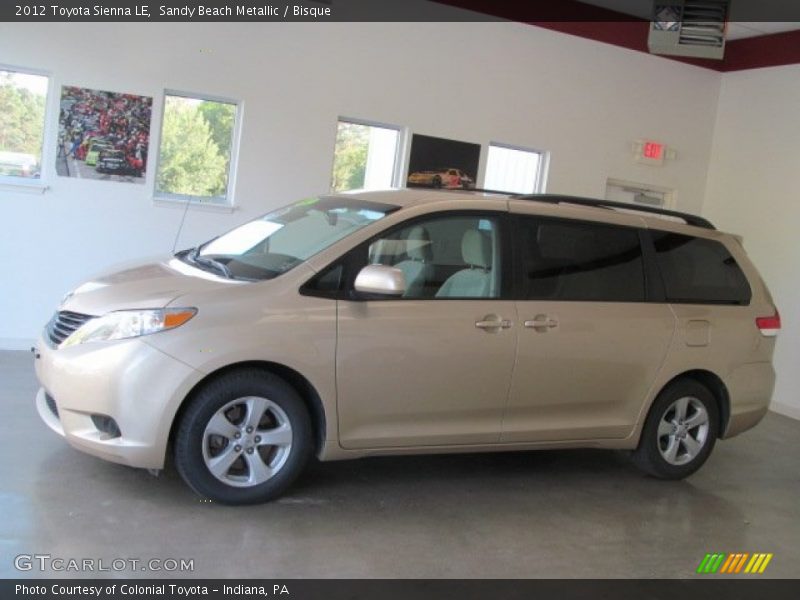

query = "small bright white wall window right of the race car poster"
[483,142,547,194]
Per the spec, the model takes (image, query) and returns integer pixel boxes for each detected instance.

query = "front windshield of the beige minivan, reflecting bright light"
[177,197,399,280]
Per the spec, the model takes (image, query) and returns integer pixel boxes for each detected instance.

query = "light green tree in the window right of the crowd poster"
[156,97,228,197]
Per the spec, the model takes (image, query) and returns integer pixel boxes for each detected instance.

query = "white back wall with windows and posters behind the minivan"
[0,23,721,347]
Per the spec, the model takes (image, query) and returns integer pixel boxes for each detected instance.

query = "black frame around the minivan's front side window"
[300,209,516,302]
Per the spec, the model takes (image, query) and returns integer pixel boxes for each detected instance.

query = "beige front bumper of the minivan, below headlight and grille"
[36,338,202,469]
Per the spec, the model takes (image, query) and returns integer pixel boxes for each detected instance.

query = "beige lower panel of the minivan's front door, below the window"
[336,300,516,448]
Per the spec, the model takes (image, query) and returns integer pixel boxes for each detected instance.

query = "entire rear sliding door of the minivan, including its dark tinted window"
[501,206,675,442]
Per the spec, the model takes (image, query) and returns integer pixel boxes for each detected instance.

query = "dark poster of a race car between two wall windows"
[406,133,481,189]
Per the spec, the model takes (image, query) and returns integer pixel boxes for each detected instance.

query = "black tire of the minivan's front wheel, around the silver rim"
[174,369,313,505]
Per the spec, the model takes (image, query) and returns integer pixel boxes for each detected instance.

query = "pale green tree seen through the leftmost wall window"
[0,71,45,159]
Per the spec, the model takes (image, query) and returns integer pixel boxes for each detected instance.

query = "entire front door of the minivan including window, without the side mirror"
[336,211,517,448]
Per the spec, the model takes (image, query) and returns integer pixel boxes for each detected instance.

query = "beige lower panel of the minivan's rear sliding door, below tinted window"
[502,301,675,442]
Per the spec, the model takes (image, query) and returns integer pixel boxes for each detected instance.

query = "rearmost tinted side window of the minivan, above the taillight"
[652,231,751,304]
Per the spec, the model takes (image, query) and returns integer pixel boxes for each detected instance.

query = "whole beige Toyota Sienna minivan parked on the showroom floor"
[35,190,780,504]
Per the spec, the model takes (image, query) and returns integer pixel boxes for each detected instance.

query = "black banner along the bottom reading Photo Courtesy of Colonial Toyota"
[0,576,800,600]
